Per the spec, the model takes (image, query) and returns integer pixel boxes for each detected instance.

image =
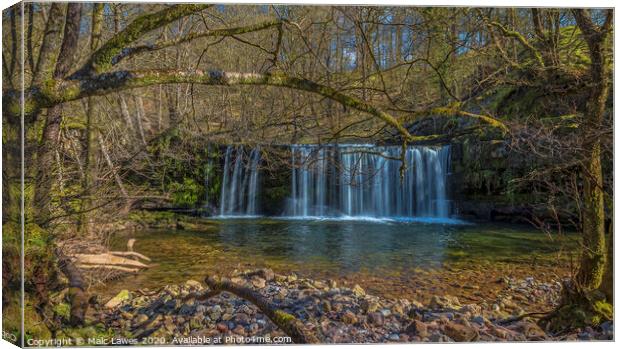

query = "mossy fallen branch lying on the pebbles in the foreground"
[199,276,319,344]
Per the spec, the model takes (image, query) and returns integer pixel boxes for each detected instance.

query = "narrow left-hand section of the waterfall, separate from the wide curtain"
[220,146,261,216]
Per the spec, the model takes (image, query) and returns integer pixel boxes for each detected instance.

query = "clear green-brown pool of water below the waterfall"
[104,218,577,295]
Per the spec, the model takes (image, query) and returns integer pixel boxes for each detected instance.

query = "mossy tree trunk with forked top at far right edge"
[542,10,613,331]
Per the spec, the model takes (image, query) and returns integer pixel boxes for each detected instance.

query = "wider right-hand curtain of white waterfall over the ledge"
[288,144,450,217]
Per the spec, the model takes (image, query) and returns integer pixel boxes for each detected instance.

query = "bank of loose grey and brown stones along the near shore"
[90,269,613,344]
